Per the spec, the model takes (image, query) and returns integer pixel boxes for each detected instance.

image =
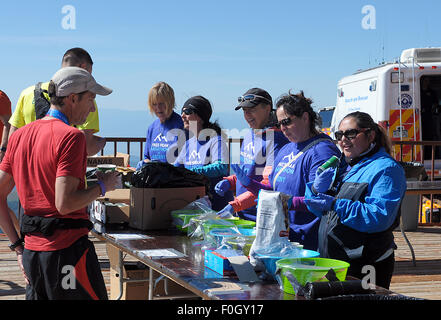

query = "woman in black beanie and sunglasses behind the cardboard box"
[174,96,233,210]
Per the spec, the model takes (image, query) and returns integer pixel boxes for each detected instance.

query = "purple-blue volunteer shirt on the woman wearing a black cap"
[236,128,289,221]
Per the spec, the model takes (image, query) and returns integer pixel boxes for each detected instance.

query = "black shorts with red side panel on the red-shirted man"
[23,236,108,300]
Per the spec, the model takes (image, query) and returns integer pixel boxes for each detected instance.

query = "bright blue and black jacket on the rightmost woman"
[305,148,406,263]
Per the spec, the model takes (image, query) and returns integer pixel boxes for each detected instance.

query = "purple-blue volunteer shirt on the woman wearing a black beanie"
[174,136,233,211]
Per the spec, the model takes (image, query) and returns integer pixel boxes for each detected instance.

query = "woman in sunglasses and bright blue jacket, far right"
[304,112,406,288]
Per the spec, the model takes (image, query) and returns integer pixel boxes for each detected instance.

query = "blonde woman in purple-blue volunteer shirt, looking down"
[136,82,184,169]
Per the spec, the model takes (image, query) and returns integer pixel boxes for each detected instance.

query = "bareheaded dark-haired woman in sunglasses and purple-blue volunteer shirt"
[231,91,341,250]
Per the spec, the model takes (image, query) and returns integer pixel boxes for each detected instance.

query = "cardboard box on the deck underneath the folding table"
[106,244,192,300]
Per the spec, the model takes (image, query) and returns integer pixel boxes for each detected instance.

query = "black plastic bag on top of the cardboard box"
[131,161,210,189]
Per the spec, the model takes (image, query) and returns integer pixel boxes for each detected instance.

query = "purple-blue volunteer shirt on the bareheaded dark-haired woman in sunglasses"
[269,134,341,250]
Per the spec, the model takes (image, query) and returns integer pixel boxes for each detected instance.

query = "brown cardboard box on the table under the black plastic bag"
[129,186,205,230]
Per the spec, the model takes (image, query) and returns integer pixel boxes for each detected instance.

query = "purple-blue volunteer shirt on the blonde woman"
[144,112,184,163]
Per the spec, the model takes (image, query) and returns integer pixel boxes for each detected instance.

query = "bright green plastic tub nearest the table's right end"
[276,258,349,294]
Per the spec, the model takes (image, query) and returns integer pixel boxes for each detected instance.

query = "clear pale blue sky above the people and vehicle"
[0,0,441,136]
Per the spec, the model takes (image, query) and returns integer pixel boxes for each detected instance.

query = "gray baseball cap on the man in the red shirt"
[51,67,112,97]
